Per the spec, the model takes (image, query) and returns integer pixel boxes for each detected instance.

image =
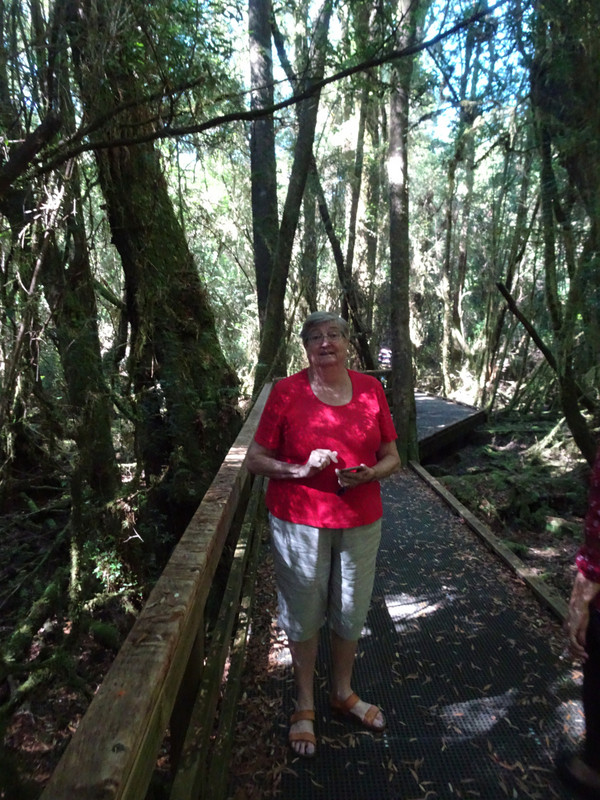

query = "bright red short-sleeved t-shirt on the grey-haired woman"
[254,369,397,528]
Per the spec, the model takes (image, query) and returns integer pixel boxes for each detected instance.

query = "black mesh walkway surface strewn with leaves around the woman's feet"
[277,471,583,800]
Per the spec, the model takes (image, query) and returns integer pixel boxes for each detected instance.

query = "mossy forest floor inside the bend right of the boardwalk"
[425,413,589,597]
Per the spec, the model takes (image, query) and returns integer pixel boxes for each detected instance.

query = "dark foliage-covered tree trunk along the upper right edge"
[531,0,600,463]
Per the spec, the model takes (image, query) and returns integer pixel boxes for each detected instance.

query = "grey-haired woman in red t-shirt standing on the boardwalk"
[248,311,400,757]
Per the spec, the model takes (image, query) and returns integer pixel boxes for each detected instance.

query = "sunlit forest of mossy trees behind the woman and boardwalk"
[0,0,600,797]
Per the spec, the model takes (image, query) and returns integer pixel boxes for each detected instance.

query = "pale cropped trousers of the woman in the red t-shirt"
[269,514,381,642]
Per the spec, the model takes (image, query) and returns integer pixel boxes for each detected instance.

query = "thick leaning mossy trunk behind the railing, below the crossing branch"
[98,134,237,500]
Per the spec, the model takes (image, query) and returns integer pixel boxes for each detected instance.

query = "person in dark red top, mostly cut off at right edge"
[556,450,600,798]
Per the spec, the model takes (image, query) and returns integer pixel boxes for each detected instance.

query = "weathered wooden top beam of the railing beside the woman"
[42,385,271,800]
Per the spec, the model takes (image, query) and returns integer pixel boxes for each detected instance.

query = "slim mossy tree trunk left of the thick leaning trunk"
[42,173,121,600]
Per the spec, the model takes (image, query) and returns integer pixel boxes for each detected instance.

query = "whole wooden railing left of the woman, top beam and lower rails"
[42,386,270,800]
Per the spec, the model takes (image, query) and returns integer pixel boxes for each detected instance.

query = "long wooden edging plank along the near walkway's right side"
[410,461,568,621]
